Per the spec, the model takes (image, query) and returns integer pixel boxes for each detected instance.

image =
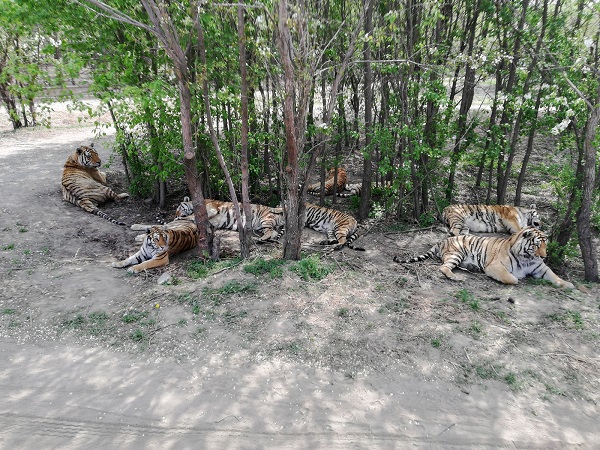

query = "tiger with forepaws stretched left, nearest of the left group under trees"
[111,219,198,273]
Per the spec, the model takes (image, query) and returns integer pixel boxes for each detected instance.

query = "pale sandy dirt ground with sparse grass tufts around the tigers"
[0,107,600,449]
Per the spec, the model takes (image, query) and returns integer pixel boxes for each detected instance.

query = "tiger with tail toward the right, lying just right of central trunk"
[304,203,364,251]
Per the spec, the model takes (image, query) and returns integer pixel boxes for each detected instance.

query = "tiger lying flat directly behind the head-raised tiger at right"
[442,205,541,236]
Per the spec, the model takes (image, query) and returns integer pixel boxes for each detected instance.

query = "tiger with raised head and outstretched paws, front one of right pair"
[394,227,575,289]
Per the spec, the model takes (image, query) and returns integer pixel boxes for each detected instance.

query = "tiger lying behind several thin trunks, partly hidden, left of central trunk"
[131,197,285,243]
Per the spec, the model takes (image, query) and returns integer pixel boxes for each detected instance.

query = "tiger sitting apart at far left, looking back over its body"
[61,144,129,225]
